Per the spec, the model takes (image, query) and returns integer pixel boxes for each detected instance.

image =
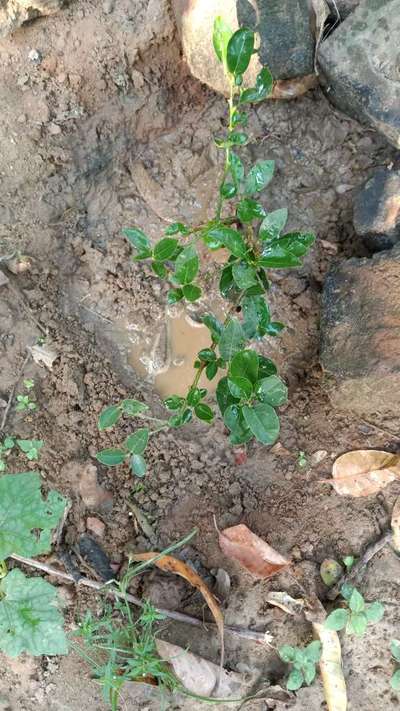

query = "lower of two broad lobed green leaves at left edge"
[0,569,68,657]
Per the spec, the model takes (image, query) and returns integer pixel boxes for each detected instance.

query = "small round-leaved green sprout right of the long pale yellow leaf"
[325,584,384,637]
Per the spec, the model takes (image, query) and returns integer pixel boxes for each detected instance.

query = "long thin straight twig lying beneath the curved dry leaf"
[10,555,265,644]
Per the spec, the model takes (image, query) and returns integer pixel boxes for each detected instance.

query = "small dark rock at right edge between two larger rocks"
[353,168,400,252]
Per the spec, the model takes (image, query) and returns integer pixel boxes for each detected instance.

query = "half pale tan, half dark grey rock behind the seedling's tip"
[173,0,315,94]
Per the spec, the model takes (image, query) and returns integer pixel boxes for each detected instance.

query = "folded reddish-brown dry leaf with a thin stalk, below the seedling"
[219,523,289,578]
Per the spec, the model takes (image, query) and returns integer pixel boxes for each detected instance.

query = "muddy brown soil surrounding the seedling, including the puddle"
[0,0,400,711]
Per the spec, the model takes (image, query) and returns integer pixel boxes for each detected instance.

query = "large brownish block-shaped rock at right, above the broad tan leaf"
[321,246,400,416]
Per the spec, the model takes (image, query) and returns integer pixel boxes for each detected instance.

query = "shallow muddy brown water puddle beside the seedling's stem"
[126,306,223,398]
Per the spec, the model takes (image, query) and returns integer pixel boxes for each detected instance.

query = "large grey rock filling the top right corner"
[318,0,400,147]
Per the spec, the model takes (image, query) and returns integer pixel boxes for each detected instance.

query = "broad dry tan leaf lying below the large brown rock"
[331,449,400,496]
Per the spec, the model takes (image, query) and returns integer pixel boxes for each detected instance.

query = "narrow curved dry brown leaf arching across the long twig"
[130,551,225,669]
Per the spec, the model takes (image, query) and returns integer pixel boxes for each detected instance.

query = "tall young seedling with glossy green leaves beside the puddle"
[97,18,315,477]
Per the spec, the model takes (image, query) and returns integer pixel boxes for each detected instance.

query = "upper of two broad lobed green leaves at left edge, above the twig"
[0,472,67,560]
